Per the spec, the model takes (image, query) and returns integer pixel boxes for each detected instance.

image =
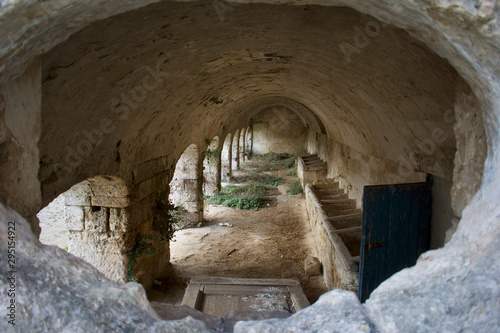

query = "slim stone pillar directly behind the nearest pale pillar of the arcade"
[203,137,222,195]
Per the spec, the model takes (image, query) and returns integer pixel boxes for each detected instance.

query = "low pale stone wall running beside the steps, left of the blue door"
[304,184,358,292]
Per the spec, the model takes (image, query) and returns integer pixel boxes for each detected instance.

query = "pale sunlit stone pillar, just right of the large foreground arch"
[169,145,203,223]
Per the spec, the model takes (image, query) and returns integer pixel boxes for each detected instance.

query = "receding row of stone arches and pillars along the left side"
[60,127,253,287]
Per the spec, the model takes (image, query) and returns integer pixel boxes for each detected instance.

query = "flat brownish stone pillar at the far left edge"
[0,59,42,237]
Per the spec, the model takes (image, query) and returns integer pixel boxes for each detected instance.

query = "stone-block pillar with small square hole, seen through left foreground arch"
[63,179,135,282]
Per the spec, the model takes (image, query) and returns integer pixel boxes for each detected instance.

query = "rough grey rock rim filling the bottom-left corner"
[0,204,209,333]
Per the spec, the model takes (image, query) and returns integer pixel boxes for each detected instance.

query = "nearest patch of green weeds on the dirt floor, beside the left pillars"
[205,181,269,210]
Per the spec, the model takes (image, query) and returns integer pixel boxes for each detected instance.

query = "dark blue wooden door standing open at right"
[358,182,432,302]
